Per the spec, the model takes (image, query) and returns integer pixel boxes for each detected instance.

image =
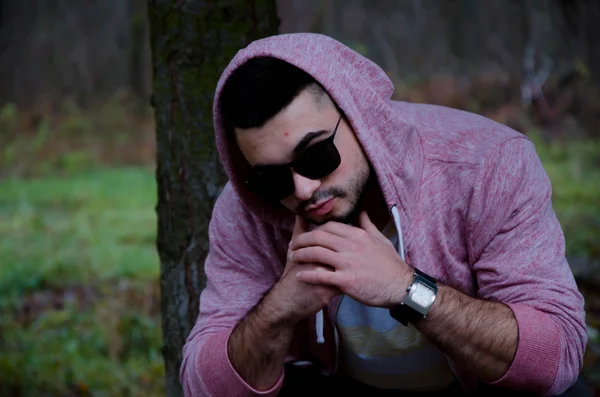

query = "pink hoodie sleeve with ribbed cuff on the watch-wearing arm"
[469,137,587,395]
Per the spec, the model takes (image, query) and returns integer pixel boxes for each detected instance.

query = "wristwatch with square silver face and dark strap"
[390,269,438,326]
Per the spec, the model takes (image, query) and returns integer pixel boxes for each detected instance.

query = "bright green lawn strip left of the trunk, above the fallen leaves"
[0,169,158,296]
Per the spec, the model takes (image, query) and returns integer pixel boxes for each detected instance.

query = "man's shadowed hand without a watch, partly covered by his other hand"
[260,216,340,325]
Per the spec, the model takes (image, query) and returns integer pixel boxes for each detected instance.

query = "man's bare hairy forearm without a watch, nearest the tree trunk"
[227,292,293,390]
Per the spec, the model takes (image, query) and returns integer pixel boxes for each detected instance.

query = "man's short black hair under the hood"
[219,56,326,128]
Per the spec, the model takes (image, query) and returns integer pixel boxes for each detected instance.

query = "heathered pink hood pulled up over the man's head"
[213,33,422,229]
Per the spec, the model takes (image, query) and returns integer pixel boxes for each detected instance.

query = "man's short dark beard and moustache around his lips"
[303,165,375,226]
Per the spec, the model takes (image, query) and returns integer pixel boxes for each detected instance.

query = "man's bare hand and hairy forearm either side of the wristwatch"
[291,213,518,382]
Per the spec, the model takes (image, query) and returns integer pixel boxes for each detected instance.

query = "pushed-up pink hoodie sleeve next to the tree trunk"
[180,186,283,397]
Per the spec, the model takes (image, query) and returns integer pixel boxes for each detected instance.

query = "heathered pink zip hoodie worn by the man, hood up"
[181,33,587,397]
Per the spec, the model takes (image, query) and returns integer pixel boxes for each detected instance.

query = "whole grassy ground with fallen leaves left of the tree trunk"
[0,168,163,396]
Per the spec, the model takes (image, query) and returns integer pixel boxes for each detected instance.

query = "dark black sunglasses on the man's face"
[245,116,342,202]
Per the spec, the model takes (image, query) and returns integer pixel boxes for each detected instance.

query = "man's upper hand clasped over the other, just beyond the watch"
[290,212,413,307]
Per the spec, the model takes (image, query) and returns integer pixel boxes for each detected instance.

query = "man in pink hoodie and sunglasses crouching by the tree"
[181,34,586,396]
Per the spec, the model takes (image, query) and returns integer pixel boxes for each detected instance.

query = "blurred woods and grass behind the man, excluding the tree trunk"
[0,0,600,397]
